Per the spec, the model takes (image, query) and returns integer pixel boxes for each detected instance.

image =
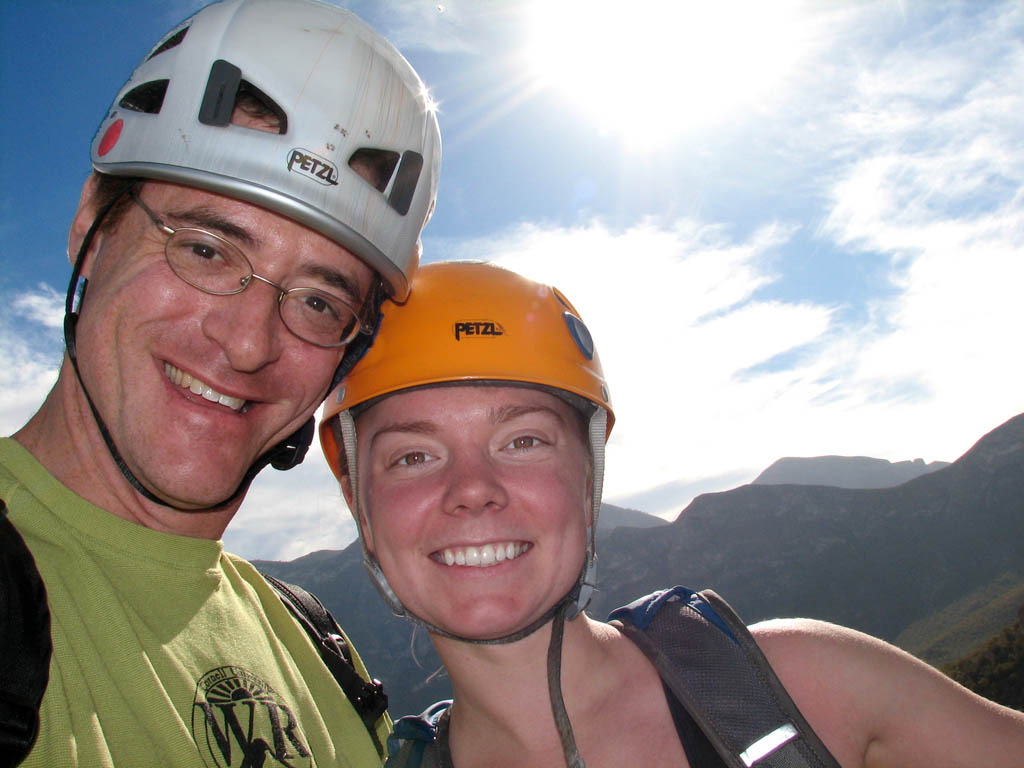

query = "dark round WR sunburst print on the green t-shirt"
[193,667,314,768]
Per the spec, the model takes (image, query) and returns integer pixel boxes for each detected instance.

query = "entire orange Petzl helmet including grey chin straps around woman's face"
[319,261,614,642]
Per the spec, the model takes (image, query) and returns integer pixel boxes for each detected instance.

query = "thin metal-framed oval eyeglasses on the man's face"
[131,195,369,347]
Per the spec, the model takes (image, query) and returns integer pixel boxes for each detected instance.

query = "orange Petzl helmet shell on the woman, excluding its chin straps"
[319,261,614,479]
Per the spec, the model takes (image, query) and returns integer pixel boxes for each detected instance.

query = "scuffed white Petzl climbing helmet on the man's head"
[92,0,440,300]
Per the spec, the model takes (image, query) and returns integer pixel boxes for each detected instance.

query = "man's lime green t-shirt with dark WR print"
[0,438,389,768]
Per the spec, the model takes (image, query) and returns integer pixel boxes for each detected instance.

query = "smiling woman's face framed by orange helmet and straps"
[356,386,591,639]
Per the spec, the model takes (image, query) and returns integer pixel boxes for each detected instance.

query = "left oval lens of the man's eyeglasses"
[167,228,252,294]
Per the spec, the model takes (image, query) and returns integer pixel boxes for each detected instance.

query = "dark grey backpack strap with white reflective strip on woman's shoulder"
[609,587,839,768]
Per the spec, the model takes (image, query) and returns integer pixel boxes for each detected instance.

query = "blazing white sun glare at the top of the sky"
[524,0,803,150]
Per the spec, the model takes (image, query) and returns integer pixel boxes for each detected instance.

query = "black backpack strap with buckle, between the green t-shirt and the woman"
[260,571,387,757]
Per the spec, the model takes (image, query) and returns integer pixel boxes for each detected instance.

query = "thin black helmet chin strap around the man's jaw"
[63,189,329,512]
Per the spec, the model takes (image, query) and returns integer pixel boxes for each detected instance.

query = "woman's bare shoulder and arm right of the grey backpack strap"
[751,618,1024,768]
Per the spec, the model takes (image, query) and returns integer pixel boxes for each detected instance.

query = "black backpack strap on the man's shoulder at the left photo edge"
[0,499,53,768]
